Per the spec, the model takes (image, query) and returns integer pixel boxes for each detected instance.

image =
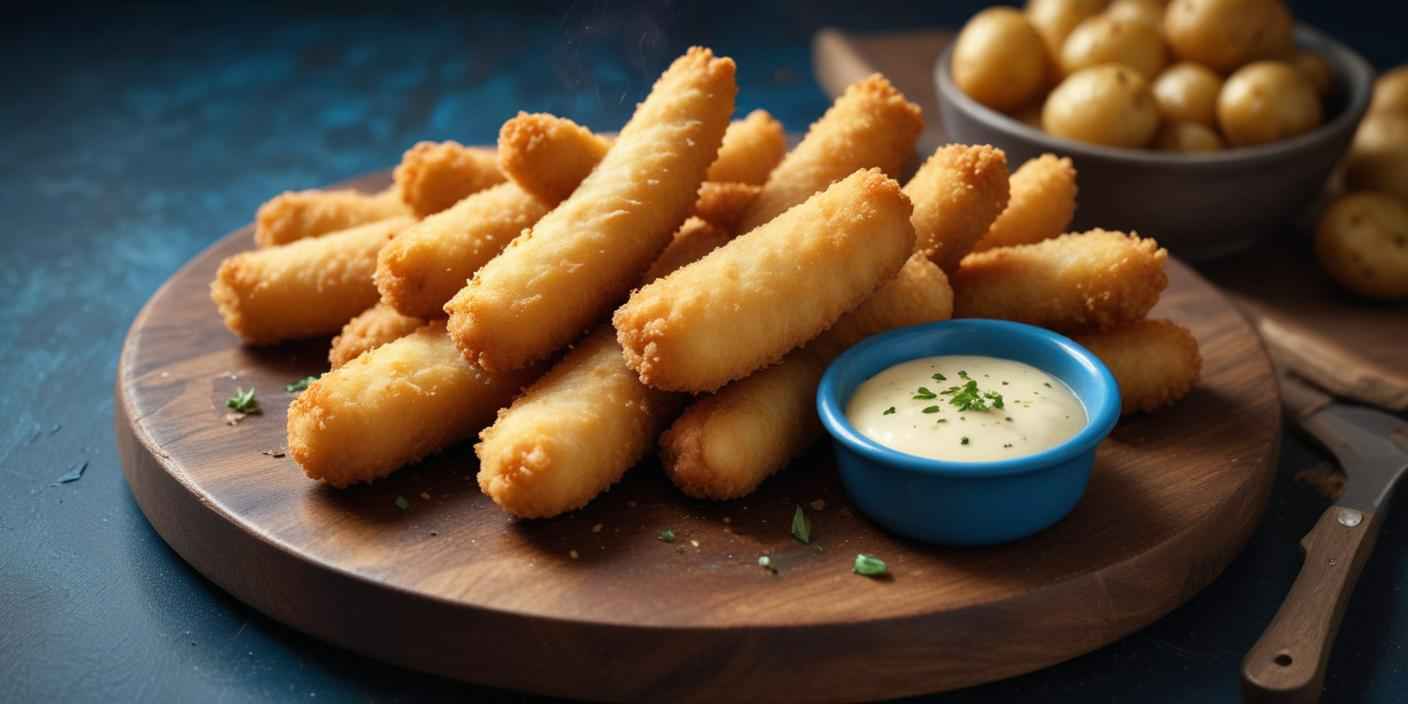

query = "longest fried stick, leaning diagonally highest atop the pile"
[445,46,738,372]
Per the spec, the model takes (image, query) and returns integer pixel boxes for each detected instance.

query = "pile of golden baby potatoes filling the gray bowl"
[952,0,1332,152]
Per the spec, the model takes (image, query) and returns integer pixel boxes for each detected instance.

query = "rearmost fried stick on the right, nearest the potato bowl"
[973,153,1076,252]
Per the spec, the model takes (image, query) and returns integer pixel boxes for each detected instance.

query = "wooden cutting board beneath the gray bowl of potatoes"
[812,30,1408,411]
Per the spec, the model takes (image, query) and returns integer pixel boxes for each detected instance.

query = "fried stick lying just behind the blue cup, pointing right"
[953,230,1169,332]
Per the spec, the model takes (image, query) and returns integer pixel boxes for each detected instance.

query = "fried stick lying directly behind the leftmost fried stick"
[255,187,410,246]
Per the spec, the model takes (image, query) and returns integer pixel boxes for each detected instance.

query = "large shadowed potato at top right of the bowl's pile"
[1163,0,1294,73]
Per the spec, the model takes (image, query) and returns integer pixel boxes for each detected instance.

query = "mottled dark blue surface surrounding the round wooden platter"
[0,1,1408,703]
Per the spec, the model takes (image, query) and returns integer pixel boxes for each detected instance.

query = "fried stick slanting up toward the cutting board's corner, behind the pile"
[738,73,924,232]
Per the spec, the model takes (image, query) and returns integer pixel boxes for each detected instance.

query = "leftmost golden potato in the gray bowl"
[953,7,1048,111]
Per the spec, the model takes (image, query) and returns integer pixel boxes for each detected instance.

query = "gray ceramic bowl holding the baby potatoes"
[935,27,1374,259]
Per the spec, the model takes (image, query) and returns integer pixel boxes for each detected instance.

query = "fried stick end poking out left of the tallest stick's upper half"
[498,113,611,206]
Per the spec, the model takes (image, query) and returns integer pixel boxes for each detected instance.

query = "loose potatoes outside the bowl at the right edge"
[1315,66,1408,300]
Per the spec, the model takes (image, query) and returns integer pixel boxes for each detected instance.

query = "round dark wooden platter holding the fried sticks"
[114,173,1280,700]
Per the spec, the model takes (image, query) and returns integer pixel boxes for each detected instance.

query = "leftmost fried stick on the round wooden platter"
[210,215,414,345]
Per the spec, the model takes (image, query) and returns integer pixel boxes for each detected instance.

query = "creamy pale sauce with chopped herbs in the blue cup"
[846,355,1086,462]
